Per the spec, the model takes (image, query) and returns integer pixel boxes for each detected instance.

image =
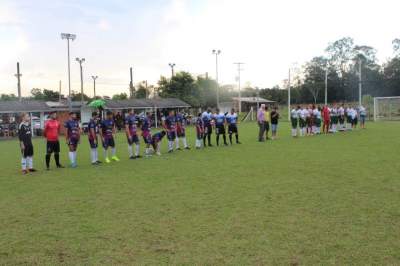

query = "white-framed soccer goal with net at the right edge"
[374,96,400,121]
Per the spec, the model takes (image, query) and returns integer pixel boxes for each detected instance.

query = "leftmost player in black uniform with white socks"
[18,113,36,174]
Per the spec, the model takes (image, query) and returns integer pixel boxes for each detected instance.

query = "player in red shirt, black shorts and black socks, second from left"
[43,112,64,170]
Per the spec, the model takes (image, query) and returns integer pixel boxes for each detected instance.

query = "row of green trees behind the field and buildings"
[0,37,400,107]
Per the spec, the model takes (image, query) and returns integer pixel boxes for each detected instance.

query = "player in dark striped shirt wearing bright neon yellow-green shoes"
[100,111,119,163]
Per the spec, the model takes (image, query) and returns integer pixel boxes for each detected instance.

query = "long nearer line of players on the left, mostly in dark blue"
[18,108,240,174]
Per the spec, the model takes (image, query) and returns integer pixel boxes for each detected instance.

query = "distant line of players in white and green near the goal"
[290,104,366,137]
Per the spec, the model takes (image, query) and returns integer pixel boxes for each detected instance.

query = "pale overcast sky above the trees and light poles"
[0,0,400,95]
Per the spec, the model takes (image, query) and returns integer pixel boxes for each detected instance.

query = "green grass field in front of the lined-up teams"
[0,123,400,265]
